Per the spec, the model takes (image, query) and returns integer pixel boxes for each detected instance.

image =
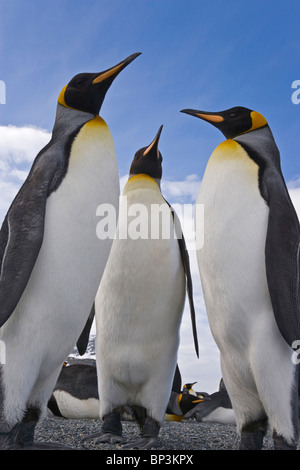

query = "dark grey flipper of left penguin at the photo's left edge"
[0,154,55,327]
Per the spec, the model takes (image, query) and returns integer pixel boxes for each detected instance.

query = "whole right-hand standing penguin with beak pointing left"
[180,107,300,449]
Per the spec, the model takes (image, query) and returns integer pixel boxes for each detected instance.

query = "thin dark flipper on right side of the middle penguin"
[165,200,199,357]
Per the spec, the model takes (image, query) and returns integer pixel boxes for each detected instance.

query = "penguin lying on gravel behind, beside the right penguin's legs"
[185,379,236,425]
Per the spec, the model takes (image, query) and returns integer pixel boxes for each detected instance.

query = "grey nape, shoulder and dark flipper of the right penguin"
[235,126,300,346]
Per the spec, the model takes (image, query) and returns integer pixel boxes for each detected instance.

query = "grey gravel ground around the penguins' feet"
[36,417,273,451]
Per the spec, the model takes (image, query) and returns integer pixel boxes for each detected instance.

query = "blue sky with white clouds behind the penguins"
[0,0,300,392]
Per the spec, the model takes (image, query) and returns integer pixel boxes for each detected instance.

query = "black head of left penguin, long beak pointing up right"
[58,52,140,114]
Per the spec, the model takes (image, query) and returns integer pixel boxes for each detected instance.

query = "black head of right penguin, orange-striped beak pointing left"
[181,106,268,139]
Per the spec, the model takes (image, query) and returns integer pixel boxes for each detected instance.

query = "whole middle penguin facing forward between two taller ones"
[82,127,198,449]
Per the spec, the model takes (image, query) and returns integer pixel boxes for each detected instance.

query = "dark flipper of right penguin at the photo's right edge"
[264,167,300,346]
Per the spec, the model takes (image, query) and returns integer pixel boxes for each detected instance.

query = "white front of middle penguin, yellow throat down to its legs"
[95,175,185,422]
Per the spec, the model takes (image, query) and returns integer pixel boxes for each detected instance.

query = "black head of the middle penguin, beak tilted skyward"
[129,126,163,179]
